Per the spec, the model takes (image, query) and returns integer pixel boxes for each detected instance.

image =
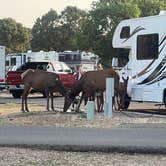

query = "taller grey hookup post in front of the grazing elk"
[104,77,114,118]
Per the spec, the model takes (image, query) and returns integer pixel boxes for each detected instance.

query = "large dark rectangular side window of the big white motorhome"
[137,34,159,60]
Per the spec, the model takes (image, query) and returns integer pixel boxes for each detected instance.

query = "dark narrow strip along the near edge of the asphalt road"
[0,144,166,154]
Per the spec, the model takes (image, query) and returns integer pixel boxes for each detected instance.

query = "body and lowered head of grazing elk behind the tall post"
[63,68,119,112]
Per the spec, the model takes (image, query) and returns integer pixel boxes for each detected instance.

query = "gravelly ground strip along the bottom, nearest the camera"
[0,148,166,166]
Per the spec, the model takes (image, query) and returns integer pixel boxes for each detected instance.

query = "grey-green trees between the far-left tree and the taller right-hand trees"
[32,6,86,51]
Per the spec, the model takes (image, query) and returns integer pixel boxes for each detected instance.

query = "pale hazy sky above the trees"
[0,0,96,28]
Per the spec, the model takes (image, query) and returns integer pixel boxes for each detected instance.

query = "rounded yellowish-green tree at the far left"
[0,18,31,53]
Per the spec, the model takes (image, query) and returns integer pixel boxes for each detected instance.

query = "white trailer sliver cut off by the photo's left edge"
[0,46,5,90]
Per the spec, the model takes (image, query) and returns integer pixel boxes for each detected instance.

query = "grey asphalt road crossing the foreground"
[0,126,166,154]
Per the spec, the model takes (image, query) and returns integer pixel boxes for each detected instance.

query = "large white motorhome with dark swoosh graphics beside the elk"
[112,14,166,105]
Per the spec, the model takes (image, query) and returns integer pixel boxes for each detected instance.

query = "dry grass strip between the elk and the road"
[0,103,166,128]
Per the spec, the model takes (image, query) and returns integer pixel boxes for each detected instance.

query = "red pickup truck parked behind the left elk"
[6,61,77,98]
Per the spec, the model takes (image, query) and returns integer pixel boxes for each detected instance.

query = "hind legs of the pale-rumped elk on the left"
[21,85,30,112]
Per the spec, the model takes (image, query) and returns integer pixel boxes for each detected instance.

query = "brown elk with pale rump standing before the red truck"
[21,69,66,112]
